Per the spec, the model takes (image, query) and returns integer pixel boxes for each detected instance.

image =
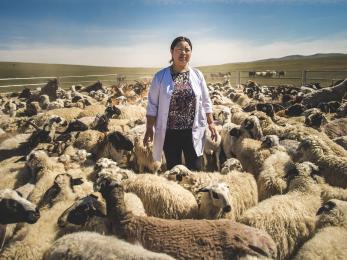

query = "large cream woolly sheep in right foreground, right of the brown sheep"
[239,162,321,259]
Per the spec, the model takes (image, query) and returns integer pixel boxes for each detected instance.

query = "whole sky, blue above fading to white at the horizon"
[0,0,347,67]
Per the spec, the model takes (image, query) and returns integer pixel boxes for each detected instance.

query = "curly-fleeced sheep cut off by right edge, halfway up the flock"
[297,137,347,188]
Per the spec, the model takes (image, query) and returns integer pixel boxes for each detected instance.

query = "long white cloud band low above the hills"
[0,35,347,67]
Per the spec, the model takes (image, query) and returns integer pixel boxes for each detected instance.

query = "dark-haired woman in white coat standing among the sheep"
[143,36,217,171]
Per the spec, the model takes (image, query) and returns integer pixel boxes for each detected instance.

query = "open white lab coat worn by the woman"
[147,67,212,161]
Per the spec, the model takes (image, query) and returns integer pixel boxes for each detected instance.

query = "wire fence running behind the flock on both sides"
[0,69,347,92]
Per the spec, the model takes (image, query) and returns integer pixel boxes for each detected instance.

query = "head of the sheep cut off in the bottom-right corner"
[317,199,347,228]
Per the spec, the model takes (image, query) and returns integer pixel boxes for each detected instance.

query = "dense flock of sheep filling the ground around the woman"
[0,75,347,259]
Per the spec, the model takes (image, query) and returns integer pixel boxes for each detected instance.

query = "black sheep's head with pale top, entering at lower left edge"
[0,189,40,225]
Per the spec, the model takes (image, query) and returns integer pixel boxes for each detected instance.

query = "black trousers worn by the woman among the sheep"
[163,129,202,171]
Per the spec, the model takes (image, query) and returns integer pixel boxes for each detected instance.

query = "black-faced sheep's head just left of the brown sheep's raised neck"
[58,194,106,227]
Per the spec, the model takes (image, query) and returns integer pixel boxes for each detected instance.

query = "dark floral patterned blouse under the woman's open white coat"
[167,69,196,129]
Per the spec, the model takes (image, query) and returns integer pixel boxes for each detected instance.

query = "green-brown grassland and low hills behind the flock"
[0,54,347,92]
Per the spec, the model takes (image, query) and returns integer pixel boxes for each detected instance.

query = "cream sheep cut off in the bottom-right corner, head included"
[294,200,347,260]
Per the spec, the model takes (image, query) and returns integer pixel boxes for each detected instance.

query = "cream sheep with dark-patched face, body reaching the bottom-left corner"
[1,174,82,259]
